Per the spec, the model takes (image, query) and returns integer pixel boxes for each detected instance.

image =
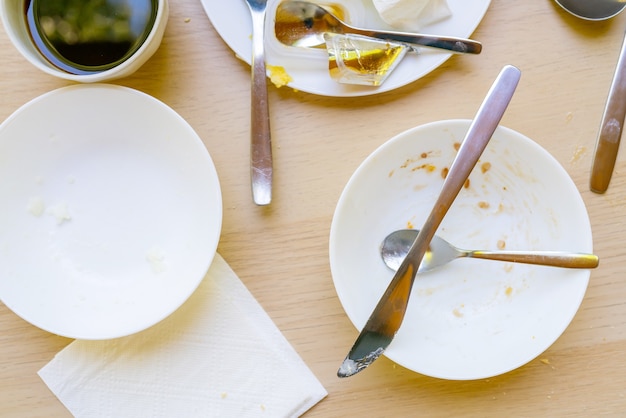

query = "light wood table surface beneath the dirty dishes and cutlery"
[0,0,626,417]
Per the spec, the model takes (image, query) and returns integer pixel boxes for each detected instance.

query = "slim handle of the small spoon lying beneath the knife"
[466,250,599,269]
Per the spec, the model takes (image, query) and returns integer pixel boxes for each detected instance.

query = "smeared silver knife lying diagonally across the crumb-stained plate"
[337,65,521,377]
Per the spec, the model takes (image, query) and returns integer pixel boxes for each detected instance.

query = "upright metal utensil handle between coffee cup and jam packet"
[250,7,273,205]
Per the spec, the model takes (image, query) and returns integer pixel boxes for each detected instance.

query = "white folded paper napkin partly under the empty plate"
[39,254,327,418]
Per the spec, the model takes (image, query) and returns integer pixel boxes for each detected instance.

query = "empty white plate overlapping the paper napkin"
[0,85,222,339]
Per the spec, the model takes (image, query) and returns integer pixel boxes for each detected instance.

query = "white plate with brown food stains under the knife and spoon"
[330,120,592,380]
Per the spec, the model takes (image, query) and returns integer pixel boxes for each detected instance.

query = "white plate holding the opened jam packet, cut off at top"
[201,0,491,97]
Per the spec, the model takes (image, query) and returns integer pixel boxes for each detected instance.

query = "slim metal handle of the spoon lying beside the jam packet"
[346,25,483,54]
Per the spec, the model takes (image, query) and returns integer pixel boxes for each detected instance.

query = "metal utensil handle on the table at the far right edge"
[589,28,626,193]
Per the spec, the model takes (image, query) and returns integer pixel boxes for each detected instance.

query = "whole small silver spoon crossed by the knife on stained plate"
[380,229,599,273]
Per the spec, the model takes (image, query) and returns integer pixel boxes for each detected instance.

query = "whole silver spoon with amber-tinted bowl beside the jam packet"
[274,1,482,54]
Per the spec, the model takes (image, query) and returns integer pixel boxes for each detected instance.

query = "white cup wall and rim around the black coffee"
[0,0,169,83]
